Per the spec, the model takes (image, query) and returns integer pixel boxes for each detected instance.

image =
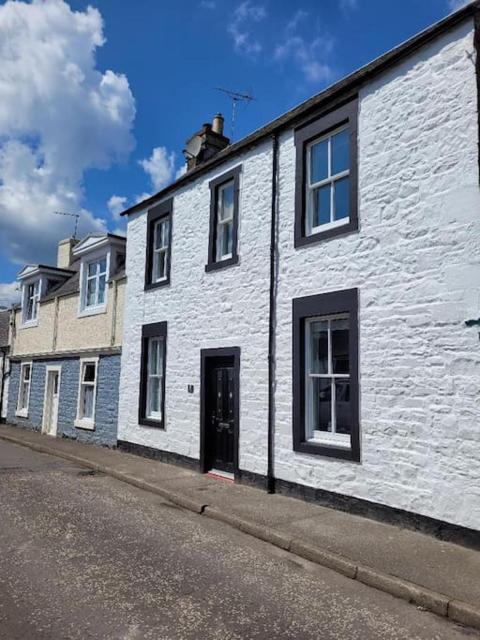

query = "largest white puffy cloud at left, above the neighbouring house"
[0,0,135,262]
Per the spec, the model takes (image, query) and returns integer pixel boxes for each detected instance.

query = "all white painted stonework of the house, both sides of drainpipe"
[119,22,480,529]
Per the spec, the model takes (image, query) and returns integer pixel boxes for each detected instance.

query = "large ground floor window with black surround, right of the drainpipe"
[293,289,360,460]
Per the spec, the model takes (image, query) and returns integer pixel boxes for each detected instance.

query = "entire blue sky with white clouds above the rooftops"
[0,0,463,304]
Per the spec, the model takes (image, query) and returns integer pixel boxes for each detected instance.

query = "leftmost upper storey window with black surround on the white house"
[145,198,173,289]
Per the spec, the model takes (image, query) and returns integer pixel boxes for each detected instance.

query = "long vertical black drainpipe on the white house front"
[267,133,278,493]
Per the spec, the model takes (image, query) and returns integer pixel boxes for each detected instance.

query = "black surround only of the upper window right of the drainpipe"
[294,98,358,247]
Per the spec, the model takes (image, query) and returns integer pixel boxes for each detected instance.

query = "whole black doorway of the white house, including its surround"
[200,347,240,475]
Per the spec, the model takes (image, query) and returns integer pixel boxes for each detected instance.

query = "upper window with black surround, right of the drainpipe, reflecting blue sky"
[295,100,358,246]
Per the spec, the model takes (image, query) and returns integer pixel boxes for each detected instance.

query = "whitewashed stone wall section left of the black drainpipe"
[118,142,272,473]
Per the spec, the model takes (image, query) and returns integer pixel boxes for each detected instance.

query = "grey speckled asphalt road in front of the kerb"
[0,441,480,640]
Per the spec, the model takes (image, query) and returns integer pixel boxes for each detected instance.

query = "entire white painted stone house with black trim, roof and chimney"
[118,3,480,535]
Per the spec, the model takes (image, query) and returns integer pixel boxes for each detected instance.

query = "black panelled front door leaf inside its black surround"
[207,366,235,473]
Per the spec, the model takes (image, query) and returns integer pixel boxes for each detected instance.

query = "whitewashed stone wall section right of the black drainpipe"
[276,23,480,529]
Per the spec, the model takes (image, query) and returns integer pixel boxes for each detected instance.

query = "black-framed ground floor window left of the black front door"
[139,322,167,428]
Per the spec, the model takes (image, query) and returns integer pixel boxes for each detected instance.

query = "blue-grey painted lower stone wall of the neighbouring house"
[7,355,120,447]
